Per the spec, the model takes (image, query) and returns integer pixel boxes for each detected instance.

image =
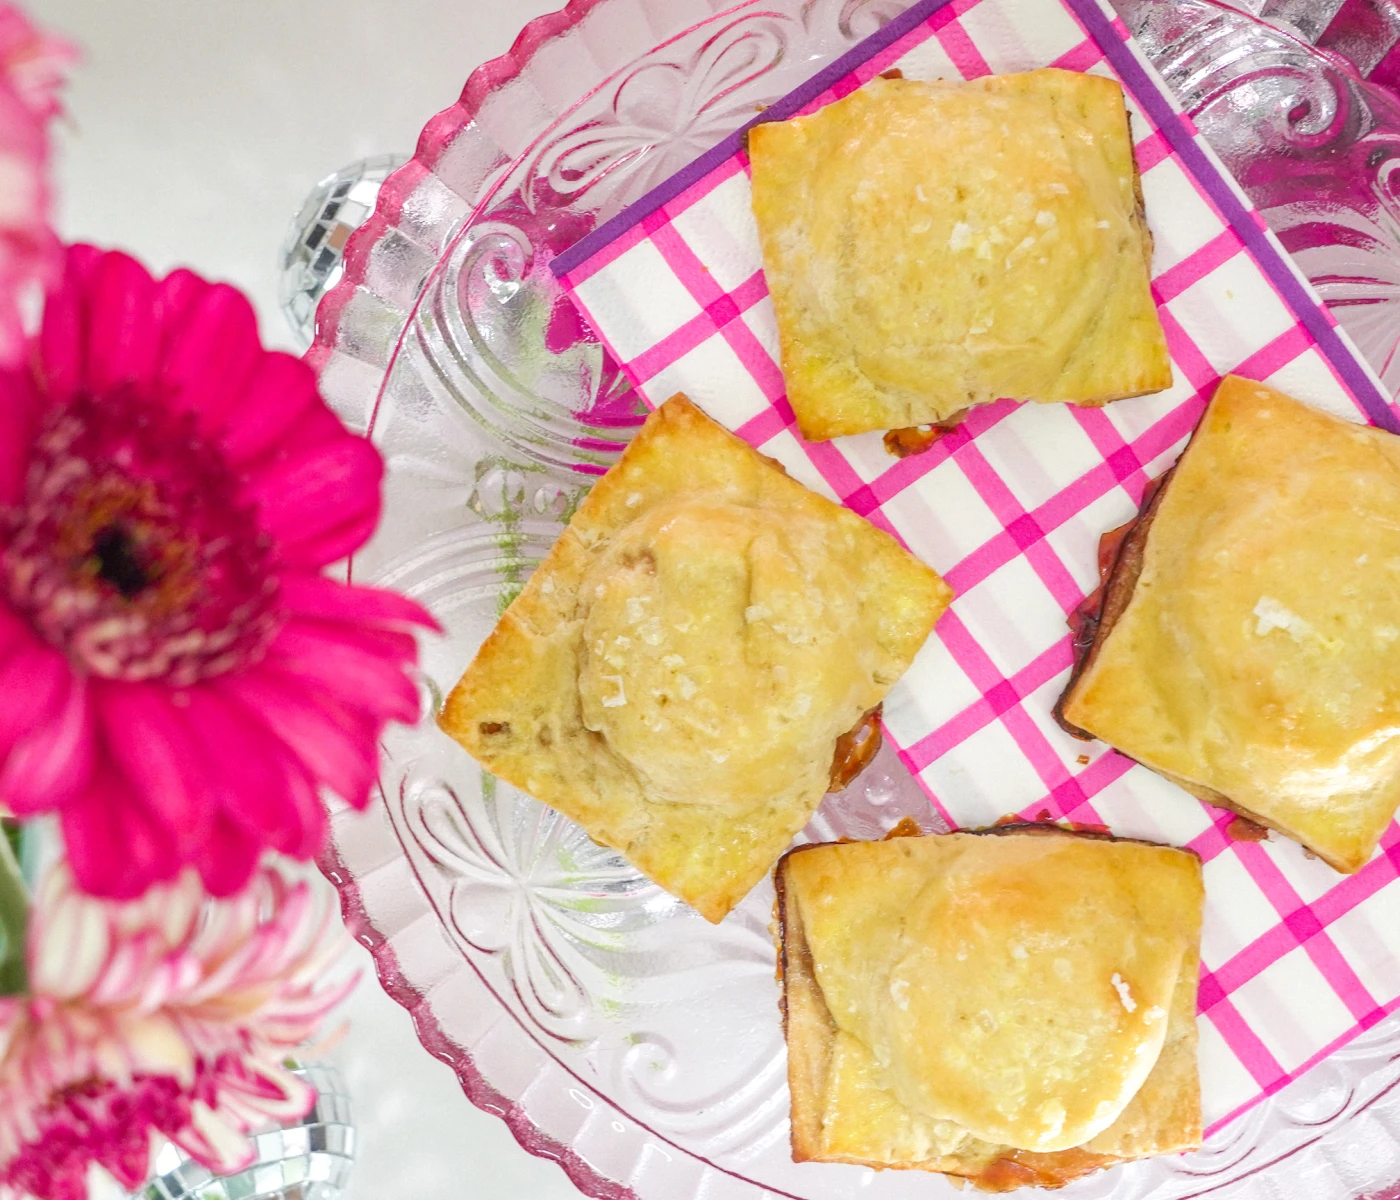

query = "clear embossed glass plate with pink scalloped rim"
[308,0,1400,1200]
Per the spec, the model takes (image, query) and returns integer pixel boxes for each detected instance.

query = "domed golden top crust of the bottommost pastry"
[785,835,1204,1152]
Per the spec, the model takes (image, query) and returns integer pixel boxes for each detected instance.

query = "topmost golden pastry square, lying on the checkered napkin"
[749,69,1172,440]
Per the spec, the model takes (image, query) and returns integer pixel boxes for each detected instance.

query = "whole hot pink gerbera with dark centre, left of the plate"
[0,246,433,898]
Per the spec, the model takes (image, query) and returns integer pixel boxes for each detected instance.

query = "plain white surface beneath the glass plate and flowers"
[43,0,588,1200]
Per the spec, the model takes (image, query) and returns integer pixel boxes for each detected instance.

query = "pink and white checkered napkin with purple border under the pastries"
[556,0,1400,1129]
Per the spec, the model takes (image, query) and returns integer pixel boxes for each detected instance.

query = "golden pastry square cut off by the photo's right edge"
[1060,375,1400,871]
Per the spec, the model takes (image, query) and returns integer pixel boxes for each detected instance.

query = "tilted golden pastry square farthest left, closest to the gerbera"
[438,396,952,921]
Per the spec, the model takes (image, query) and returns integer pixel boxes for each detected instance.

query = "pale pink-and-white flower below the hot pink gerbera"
[0,865,354,1200]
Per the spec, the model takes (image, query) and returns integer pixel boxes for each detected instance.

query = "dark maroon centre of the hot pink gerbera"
[0,389,279,686]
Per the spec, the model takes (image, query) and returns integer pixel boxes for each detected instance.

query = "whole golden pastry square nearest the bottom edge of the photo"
[776,826,1204,1192]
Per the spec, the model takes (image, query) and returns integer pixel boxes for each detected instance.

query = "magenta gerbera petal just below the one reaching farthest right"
[267,620,419,724]
